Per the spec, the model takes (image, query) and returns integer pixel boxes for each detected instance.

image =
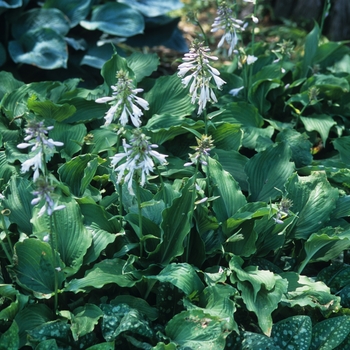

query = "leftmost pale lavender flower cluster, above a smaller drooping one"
[17,120,63,181]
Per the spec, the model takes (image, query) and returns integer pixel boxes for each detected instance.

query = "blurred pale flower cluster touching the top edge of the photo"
[211,1,244,56]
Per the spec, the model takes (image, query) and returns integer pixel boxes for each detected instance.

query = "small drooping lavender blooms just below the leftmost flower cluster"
[31,177,65,216]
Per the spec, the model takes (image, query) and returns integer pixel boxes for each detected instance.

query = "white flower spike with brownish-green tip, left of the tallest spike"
[95,71,148,128]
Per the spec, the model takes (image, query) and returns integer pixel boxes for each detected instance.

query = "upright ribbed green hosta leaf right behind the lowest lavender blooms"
[32,197,92,275]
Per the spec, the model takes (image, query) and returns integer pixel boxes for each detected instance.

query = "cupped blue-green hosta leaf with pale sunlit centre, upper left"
[8,28,68,69]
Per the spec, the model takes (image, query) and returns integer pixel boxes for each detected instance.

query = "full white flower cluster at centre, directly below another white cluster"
[111,129,167,195]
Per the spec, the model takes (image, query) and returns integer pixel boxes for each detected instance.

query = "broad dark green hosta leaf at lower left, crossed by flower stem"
[12,238,65,298]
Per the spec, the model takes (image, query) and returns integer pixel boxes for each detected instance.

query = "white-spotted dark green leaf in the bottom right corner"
[310,316,350,350]
